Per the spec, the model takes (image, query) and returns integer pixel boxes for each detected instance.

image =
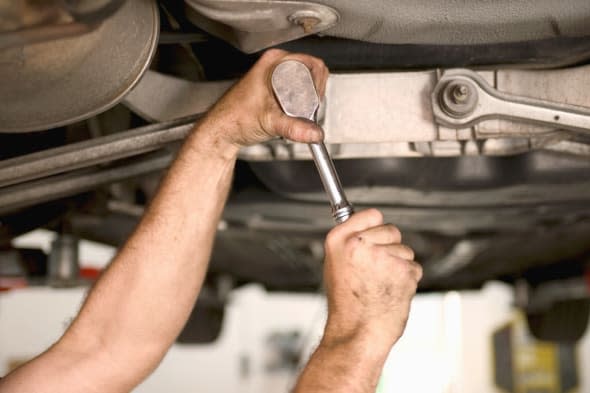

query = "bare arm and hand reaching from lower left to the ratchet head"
[0,51,327,393]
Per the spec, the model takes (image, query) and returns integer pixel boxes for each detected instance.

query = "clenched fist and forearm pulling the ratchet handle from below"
[295,209,422,393]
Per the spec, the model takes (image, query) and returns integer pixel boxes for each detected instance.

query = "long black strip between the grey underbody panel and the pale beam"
[279,36,590,71]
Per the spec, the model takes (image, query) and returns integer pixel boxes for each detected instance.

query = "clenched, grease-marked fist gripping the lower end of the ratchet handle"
[324,209,422,351]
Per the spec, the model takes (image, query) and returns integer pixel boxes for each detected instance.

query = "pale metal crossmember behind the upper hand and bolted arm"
[122,66,590,159]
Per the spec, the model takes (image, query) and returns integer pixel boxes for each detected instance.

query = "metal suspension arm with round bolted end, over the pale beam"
[431,70,590,133]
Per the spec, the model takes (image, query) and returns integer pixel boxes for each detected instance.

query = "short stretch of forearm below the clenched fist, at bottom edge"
[293,333,390,393]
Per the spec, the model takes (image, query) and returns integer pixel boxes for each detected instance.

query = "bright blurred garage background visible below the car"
[0,230,590,393]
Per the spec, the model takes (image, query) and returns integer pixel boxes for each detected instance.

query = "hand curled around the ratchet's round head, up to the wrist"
[204,49,329,147]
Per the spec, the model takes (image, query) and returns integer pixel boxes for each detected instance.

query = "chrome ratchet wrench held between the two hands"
[271,60,354,224]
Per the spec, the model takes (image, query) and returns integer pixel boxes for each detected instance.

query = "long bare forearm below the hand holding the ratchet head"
[62,124,237,386]
